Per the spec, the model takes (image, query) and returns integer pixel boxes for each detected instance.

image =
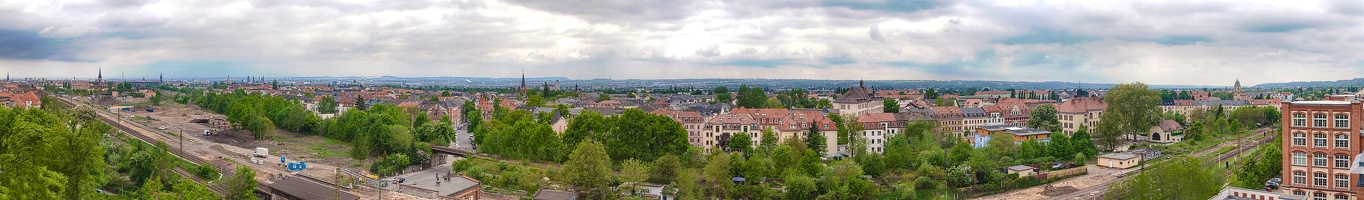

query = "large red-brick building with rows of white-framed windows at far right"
[1279,98,1364,200]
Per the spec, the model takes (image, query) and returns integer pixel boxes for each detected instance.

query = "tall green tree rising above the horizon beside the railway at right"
[1098,82,1161,150]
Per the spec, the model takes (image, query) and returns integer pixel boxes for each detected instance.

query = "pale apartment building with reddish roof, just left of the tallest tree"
[1056,97,1108,136]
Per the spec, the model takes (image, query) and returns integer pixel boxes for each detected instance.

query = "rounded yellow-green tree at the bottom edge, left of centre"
[563,140,615,199]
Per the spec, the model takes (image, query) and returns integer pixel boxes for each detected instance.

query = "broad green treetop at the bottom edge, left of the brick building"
[1105,155,1222,200]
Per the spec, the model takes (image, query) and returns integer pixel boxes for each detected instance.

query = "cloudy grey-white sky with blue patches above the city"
[0,0,1364,86]
